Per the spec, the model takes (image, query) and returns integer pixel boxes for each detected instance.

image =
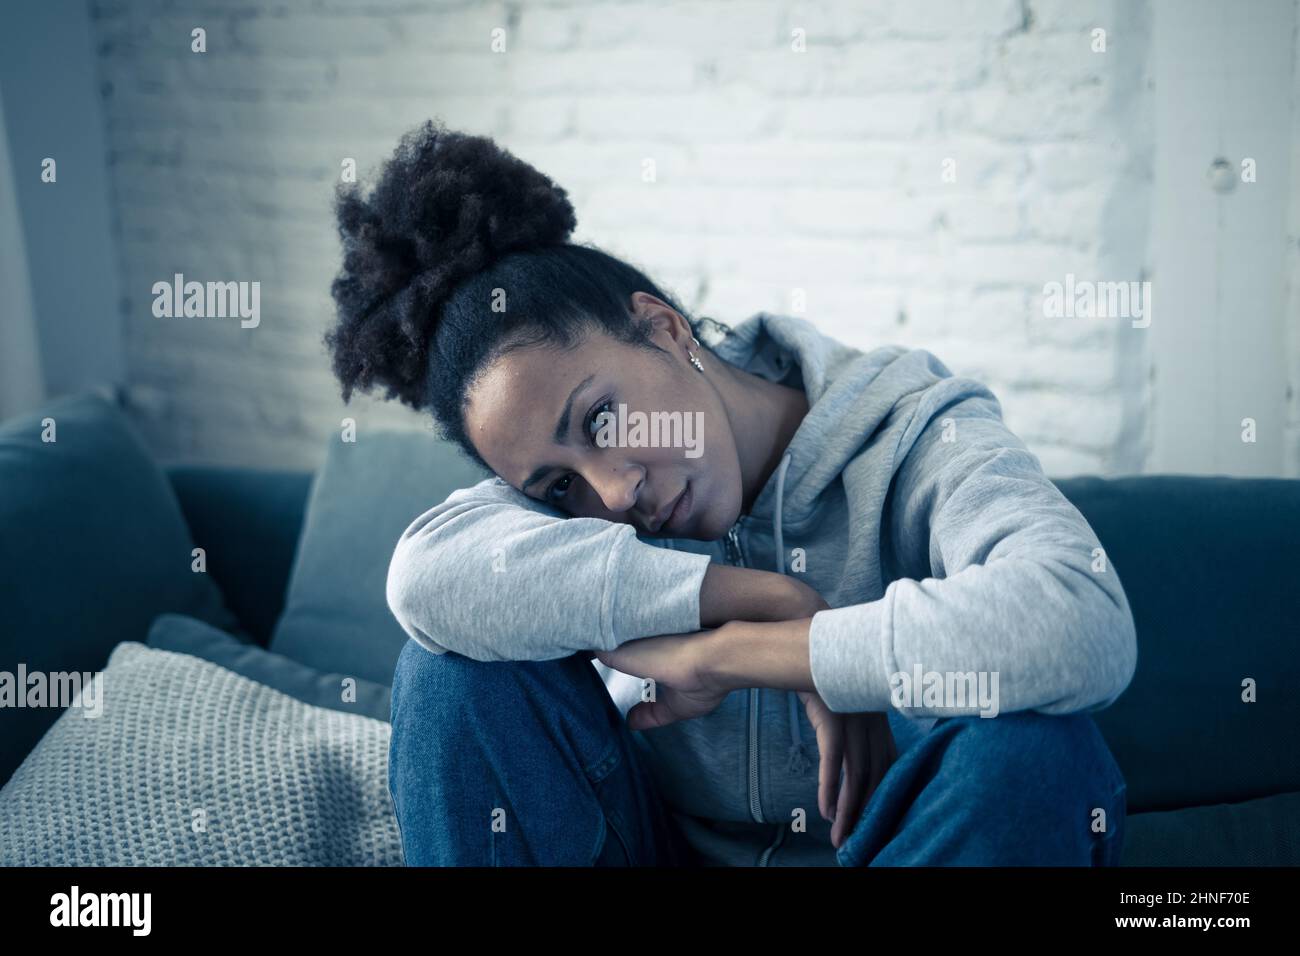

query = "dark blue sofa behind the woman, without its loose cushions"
[168,466,1300,866]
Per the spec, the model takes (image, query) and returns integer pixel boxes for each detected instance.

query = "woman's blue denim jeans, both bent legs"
[389,640,1126,866]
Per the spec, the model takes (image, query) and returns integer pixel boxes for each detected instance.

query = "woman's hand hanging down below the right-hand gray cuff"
[798,691,898,849]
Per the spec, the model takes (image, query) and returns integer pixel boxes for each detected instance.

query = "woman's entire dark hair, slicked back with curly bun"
[325,121,698,471]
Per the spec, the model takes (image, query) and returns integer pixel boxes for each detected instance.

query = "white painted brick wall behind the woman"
[94,0,1159,476]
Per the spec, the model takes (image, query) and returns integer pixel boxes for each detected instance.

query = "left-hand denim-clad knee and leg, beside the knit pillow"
[389,641,689,866]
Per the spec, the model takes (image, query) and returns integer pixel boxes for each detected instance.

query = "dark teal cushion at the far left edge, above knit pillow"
[0,393,238,782]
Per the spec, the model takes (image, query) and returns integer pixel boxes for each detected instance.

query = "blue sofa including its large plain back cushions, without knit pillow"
[0,397,1300,866]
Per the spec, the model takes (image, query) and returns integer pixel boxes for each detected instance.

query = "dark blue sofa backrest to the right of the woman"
[1057,475,1300,813]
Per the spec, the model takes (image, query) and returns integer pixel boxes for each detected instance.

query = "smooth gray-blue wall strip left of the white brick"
[0,0,126,407]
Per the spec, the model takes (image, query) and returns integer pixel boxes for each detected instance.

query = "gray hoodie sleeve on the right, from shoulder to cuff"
[809,359,1138,717]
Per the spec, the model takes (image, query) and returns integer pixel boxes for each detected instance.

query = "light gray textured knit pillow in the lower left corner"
[0,641,402,866]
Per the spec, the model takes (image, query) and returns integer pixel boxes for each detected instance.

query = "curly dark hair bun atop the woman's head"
[325,121,577,408]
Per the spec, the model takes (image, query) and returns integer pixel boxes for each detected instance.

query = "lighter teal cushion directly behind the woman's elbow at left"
[270,431,490,685]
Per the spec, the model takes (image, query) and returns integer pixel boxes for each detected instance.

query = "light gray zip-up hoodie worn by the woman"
[387,312,1138,866]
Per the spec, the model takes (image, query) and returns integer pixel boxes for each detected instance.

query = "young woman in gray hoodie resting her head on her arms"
[326,122,1136,866]
